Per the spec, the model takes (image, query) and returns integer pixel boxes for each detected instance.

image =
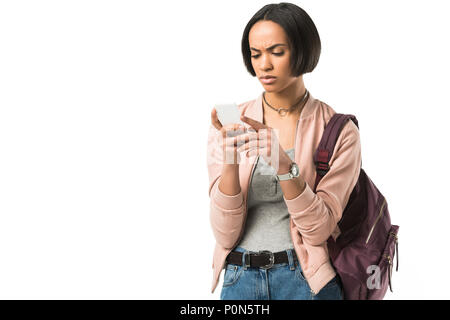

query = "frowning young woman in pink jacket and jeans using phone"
[208,3,361,300]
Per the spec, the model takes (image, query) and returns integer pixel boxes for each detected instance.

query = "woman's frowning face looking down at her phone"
[249,20,297,92]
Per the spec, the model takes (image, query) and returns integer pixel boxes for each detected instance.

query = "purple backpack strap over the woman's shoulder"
[313,113,359,192]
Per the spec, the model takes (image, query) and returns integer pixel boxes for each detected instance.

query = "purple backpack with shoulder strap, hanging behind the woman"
[314,113,399,300]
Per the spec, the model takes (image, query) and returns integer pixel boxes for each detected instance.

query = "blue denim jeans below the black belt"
[220,247,343,300]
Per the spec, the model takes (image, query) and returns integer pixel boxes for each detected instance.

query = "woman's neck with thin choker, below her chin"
[263,76,306,113]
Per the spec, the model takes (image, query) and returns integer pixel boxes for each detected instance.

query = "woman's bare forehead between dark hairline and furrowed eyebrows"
[248,20,288,50]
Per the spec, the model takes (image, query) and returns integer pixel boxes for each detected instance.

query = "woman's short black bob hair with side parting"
[241,2,321,77]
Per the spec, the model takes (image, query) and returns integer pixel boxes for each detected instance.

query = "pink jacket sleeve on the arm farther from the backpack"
[207,124,245,249]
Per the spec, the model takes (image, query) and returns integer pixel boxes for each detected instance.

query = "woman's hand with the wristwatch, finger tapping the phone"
[237,115,292,174]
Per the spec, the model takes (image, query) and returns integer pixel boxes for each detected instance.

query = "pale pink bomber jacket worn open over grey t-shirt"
[207,93,361,294]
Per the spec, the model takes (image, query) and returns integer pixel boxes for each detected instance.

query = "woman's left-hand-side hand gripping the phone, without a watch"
[211,108,246,165]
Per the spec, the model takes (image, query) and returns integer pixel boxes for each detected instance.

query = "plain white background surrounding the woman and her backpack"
[0,1,450,299]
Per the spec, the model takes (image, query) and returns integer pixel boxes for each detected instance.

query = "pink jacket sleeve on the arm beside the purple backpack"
[284,120,361,246]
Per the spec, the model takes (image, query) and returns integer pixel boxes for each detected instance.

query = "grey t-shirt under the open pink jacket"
[238,148,294,252]
